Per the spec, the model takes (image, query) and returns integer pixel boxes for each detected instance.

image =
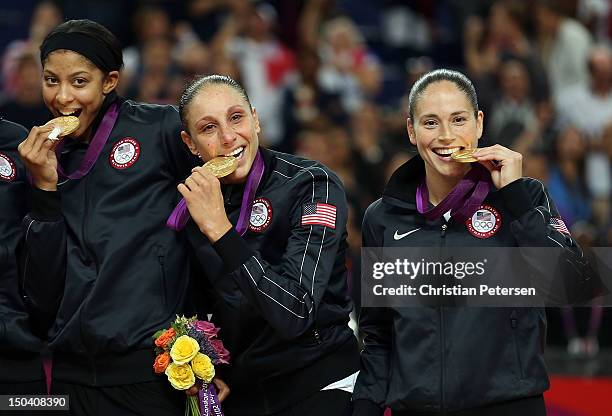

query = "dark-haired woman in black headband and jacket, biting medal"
[19,20,226,415]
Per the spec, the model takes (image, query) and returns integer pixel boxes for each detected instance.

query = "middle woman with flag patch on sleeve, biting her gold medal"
[168,75,359,416]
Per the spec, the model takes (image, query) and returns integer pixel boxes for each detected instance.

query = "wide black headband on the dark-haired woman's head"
[40,32,121,73]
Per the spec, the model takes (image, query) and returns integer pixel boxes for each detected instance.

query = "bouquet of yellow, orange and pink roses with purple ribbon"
[153,316,229,416]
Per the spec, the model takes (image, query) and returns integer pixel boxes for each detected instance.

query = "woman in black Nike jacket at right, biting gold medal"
[353,69,595,416]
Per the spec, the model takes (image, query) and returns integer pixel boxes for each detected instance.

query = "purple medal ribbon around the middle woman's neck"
[166,150,264,235]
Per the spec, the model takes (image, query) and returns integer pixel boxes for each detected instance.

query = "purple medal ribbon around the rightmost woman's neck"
[416,163,492,222]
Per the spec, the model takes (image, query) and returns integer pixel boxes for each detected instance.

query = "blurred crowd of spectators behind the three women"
[0,0,612,357]
